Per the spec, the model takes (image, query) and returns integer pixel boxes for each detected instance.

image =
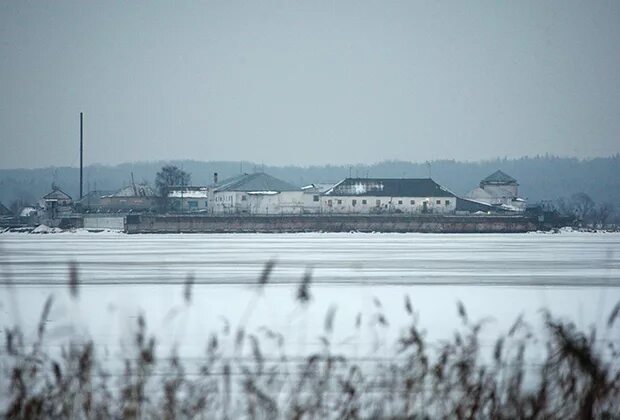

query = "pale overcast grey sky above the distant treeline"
[0,0,620,168]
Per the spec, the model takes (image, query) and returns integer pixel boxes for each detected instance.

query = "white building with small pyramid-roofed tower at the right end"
[465,170,527,211]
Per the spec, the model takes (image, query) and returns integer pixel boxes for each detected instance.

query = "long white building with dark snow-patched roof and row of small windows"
[320,178,456,214]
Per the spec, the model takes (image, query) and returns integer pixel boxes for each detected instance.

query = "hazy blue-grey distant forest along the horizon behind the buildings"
[0,154,620,212]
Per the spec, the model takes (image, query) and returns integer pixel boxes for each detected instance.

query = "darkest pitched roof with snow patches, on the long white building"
[325,178,454,197]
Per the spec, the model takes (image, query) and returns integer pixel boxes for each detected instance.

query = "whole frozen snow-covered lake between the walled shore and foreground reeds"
[0,232,620,357]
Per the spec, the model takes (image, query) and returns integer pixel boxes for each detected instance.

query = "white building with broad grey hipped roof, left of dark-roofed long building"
[209,173,306,215]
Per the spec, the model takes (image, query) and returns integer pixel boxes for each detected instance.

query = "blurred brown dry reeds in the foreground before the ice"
[0,263,620,419]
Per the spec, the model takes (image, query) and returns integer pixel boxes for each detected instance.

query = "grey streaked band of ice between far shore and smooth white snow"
[0,232,620,286]
